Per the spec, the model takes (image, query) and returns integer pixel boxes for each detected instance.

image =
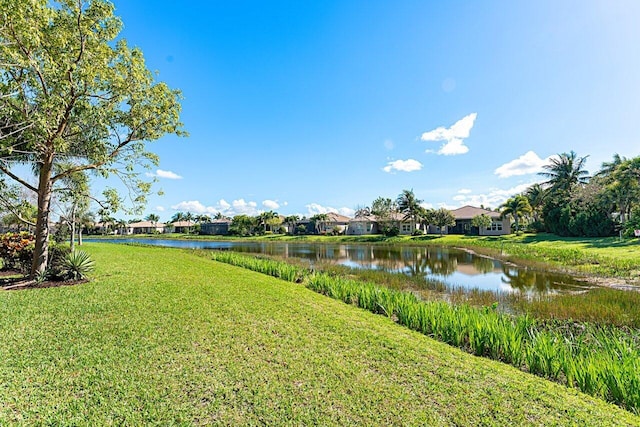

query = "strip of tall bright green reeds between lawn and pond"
[213,252,640,413]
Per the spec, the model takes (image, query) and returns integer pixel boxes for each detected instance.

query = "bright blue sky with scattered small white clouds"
[106,0,640,220]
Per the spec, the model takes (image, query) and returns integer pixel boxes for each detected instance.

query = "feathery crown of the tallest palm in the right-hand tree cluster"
[539,151,589,193]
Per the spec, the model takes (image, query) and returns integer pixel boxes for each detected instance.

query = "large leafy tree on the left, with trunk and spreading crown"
[0,0,183,277]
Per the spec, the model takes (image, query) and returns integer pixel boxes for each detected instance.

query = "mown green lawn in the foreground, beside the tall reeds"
[0,244,640,426]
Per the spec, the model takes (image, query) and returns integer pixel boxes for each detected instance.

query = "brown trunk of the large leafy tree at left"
[30,159,53,278]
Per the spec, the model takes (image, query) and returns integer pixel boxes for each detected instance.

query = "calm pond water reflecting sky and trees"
[94,238,589,294]
